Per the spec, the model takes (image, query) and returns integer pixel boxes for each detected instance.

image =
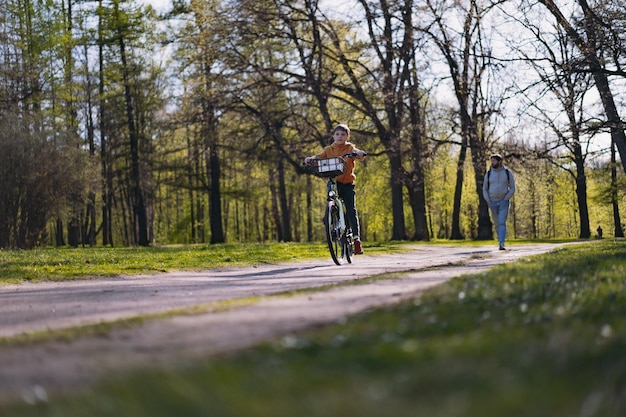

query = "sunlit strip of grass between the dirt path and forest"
[0,242,402,284]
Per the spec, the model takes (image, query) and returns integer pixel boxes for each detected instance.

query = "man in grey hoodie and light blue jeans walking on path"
[483,154,515,250]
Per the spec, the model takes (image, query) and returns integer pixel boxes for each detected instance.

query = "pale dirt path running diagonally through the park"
[0,244,560,402]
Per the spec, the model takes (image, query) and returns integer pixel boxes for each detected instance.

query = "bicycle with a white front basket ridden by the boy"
[304,152,358,265]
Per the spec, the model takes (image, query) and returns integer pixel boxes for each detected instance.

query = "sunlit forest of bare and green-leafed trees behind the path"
[0,0,626,248]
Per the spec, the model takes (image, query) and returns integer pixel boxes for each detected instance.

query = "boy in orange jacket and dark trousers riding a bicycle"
[304,124,365,255]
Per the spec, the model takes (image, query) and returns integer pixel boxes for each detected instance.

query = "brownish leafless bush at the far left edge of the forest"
[0,112,83,249]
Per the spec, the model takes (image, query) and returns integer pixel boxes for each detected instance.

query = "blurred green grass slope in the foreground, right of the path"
[0,240,626,417]
